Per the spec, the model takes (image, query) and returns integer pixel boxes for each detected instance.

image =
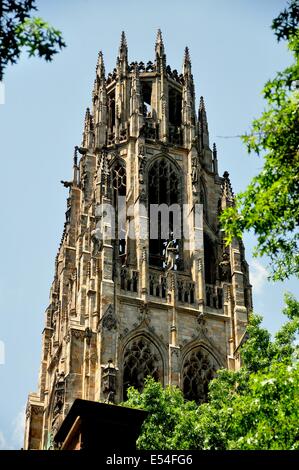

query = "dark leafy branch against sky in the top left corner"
[0,0,66,80]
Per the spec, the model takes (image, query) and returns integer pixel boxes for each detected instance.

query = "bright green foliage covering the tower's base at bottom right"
[123,294,299,450]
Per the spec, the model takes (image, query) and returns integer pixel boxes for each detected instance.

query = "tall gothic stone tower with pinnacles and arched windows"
[25,31,251,449]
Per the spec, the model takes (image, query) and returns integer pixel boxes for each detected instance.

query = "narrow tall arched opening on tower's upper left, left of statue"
[112,162,126,258]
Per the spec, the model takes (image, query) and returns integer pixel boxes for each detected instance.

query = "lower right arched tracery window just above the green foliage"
[183,347,217,403]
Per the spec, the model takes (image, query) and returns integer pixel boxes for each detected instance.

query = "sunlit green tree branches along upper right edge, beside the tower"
[220,0,299,280]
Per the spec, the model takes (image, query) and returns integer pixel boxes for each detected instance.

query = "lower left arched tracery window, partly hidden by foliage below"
[123,336,163,400]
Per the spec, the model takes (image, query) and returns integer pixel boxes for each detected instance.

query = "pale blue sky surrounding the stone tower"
[0,0,298,449]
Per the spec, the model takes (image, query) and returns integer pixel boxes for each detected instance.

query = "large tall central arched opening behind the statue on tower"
[148,157,183,268]
